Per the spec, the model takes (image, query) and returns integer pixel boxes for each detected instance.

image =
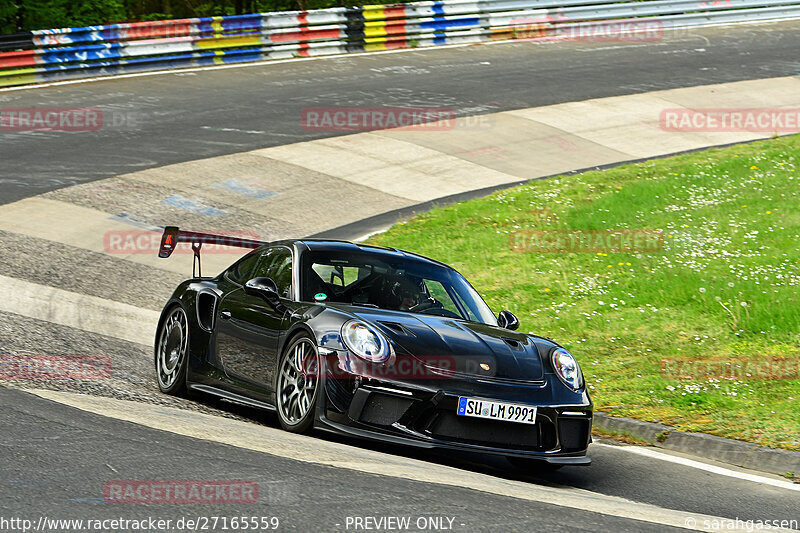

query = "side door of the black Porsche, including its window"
[215,246,292,398]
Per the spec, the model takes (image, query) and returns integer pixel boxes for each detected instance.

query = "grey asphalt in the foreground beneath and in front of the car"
[0,389,800,531]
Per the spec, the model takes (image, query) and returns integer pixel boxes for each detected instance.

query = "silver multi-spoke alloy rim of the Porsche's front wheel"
[277,338,319,426]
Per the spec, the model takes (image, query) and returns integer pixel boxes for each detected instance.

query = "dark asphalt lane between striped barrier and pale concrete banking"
[0,22,800,203]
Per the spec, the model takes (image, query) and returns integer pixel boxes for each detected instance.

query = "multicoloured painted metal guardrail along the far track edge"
[0,0,800,87]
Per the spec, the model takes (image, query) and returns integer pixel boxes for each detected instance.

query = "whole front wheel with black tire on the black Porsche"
[275,334,320,433]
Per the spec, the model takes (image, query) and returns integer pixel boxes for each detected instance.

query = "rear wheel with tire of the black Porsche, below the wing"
[155,305,189,396]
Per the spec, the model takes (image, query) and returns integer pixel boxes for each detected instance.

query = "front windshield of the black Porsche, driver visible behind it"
[300,251,497,325]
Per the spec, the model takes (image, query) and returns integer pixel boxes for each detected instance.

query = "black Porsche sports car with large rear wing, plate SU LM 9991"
[155,227,592,468]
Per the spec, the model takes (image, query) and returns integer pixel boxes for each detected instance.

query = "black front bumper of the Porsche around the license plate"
[319,350,592,465]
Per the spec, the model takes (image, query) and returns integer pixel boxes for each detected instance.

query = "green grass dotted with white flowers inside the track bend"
[371,136,800,450]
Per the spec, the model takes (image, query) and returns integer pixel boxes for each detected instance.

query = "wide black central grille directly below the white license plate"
[429,411,556,451]
